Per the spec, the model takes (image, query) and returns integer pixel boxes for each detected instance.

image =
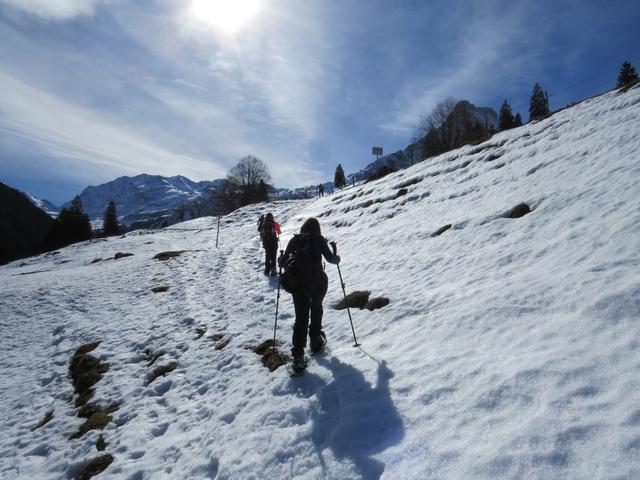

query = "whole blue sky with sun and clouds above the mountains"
[0,0,640,203]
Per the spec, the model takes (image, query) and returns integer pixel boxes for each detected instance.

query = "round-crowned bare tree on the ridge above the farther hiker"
[220,155,271,210]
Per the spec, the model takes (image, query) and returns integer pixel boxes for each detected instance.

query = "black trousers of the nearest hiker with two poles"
[291,272,328,357]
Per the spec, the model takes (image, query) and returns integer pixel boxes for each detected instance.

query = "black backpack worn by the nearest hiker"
[280,233,316,296]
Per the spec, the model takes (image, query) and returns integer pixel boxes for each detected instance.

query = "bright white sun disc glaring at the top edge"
[190,0,261,34]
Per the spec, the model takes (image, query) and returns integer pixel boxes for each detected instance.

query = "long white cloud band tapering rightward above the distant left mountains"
[0,71,224,182]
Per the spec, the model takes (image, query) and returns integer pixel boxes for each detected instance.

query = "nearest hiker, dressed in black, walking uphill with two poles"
[281,218,340,371]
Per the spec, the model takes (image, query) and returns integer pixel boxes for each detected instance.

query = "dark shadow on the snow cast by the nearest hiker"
[312,357,404,480]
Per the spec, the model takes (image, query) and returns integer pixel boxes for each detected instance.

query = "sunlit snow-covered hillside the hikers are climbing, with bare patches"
[0,87,640,480]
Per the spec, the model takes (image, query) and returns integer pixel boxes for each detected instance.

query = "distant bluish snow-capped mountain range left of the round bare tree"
[63,174,222,225]
